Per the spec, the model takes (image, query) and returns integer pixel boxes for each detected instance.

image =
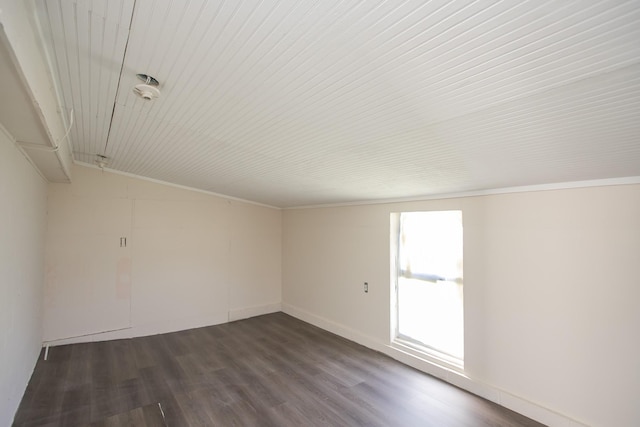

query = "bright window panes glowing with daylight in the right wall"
[397,211,464,362]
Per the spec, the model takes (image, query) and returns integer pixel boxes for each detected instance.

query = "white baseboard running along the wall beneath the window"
[282,302,586,427]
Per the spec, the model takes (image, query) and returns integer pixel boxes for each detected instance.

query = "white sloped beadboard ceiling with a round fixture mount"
[35,0,640,207]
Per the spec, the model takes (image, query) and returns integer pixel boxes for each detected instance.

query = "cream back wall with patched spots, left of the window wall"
[44,166,281,341]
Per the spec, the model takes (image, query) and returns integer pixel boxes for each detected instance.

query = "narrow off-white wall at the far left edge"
[0,126,47,426]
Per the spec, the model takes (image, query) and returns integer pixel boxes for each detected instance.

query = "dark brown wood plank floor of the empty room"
[14,313,541,427]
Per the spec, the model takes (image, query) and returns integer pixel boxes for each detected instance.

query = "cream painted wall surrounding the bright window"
[283,185,640,426]
